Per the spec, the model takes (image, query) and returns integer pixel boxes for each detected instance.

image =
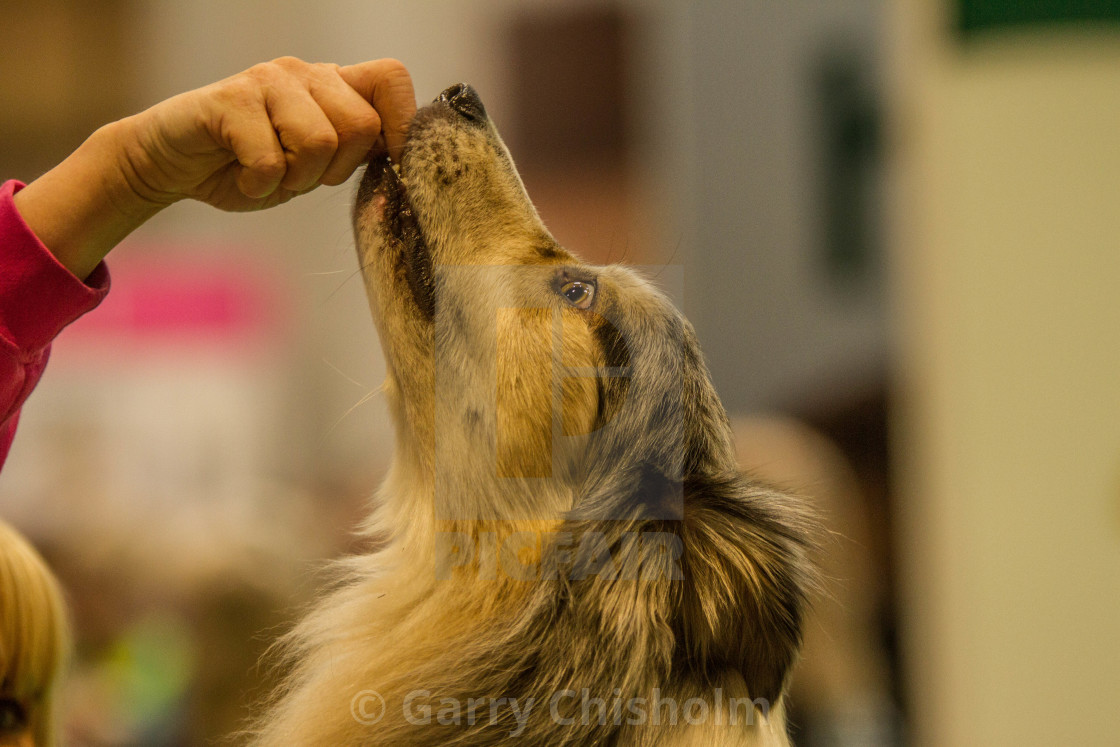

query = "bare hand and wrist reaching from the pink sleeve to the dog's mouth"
[15,57,416,279]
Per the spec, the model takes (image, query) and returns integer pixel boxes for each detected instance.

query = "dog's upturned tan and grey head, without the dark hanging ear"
[355,85,734,516]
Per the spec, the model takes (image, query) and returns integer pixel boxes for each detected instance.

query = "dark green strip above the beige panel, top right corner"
[956,0,1120,34]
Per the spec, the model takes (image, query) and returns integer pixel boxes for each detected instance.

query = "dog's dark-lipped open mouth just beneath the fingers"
[355,156,436,321]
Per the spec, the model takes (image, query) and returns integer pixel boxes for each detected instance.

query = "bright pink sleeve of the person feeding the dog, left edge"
[0,181,109,466]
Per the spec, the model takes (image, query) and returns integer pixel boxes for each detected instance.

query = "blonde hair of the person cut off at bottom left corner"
[0,521,71,747]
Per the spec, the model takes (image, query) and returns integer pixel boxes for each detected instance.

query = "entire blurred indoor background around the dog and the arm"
[0,0,1120,746]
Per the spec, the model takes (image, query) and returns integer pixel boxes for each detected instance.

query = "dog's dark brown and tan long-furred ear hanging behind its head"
[675,476,815,704]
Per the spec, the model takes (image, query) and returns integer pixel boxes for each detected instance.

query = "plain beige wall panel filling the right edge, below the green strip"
[892,0,1120,747]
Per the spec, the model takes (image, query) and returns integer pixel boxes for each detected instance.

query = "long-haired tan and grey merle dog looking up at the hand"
[251,84,813,747]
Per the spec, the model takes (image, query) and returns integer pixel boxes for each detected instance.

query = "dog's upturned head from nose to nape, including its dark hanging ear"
[354,85,805,698]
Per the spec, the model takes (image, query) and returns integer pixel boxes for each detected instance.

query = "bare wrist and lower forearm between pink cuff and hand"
[15,118,164,280]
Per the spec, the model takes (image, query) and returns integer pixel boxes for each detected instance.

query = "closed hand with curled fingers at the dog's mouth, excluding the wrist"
[116,57,416,211]
